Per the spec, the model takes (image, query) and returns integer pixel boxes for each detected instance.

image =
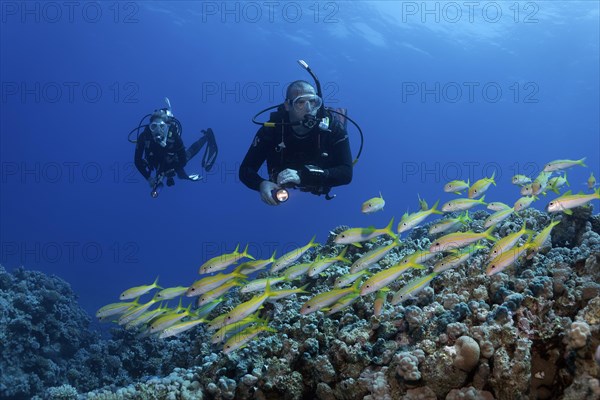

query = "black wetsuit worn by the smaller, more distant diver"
[134,126,206,179]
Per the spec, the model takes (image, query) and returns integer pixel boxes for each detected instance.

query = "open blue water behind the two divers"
[0,1,600,322]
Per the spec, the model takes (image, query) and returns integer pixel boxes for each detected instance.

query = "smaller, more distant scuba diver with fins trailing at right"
[129,98,218,197]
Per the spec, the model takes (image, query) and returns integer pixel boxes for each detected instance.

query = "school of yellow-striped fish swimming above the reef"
[96,158,600,354]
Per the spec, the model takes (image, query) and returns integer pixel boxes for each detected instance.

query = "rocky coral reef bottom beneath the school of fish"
[0,209,600,400]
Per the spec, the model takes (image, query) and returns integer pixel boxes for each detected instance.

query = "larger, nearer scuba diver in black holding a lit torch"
[239,61,362,205]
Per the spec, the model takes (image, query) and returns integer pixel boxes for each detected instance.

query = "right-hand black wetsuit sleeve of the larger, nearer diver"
[300,127,352,187]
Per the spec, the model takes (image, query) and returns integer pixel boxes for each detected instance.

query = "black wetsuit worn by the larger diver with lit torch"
[239,113,352,194]
